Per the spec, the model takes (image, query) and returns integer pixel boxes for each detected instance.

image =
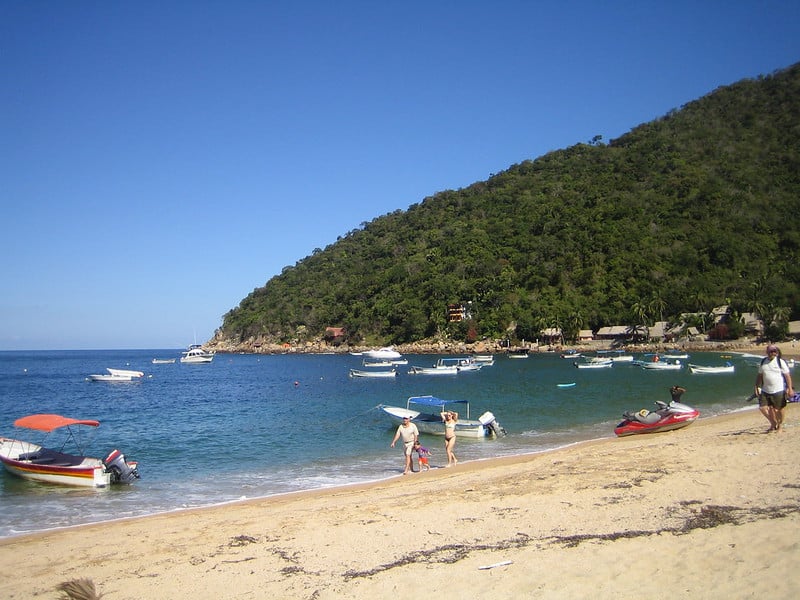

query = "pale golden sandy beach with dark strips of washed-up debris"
[0,404,800,600]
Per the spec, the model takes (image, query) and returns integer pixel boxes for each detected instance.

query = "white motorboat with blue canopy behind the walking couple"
[380,396,506,438]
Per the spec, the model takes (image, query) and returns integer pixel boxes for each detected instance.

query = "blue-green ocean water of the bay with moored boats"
[0,350,756,537]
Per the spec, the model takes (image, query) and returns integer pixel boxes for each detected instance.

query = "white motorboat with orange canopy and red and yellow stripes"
[0,414,139,487]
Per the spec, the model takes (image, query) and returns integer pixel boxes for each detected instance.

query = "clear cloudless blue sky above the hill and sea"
[0,0,800,350]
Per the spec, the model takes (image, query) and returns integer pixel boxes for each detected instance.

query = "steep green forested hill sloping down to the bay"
[220,64,800,343]
